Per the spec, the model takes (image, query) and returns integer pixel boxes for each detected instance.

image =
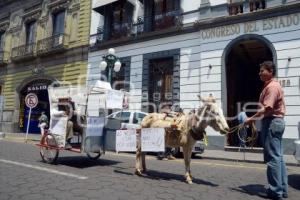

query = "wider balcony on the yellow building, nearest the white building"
[37,34,69,55]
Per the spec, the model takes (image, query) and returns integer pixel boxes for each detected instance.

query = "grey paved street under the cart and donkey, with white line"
[0,138,300,200]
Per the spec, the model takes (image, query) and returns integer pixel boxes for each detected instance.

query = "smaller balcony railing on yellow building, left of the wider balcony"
[11,43,36,60]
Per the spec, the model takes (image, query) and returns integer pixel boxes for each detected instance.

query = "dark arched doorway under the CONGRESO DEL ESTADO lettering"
[223,35,276,147]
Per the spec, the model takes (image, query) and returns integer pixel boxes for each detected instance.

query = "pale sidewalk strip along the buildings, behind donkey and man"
[0,132,300,166]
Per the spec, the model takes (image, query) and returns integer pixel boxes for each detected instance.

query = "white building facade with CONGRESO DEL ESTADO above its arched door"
[87,0,300,153]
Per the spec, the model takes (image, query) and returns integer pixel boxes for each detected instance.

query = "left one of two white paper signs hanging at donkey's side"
[116,129,136,152]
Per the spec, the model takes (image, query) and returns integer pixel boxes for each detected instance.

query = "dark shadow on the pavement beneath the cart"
[44,156,121,169]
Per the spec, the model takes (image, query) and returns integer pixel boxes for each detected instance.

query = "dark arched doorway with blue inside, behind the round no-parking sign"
[17,79,53,134]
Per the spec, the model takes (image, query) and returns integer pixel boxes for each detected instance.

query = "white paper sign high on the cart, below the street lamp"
[106,90,124,109]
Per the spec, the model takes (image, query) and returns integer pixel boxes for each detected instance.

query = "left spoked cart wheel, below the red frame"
[40,134,59,164]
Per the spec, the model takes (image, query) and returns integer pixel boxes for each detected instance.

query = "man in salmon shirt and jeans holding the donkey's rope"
[245,61,288,200]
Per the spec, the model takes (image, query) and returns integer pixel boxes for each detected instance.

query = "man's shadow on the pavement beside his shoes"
[231,184,266,198]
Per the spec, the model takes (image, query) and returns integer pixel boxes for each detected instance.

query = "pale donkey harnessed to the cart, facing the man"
[135,94,229,184]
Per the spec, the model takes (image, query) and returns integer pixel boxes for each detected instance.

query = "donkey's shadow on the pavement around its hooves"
[133,170,219,187]
